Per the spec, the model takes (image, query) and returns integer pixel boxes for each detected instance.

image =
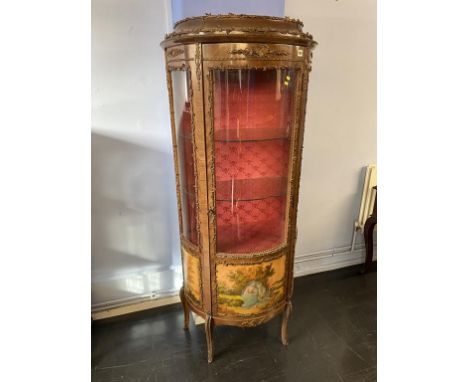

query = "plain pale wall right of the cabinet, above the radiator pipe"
[285,0,377,257]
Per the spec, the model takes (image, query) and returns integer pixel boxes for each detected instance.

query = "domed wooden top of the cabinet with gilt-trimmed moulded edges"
[161,13,317,48]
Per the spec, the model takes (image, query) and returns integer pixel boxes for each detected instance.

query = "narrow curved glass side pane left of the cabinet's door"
[171,70,198,245]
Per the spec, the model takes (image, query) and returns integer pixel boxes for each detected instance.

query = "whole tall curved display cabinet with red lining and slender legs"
[161,14,316,362]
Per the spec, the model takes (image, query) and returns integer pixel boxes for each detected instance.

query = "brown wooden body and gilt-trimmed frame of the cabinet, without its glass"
[161,14,316,362]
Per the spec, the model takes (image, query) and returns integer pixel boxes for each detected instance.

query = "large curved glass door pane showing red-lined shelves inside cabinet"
[213,69,296,253]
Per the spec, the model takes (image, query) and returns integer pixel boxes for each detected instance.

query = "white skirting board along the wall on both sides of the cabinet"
[91,245,377,325]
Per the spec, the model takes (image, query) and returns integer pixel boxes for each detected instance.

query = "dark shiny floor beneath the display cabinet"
[91,263,377,382]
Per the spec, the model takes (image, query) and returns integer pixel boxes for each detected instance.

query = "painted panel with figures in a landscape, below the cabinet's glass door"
[216,256,286,315]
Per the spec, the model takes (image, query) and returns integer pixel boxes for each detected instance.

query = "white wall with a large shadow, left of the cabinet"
[91,0,181,306]
